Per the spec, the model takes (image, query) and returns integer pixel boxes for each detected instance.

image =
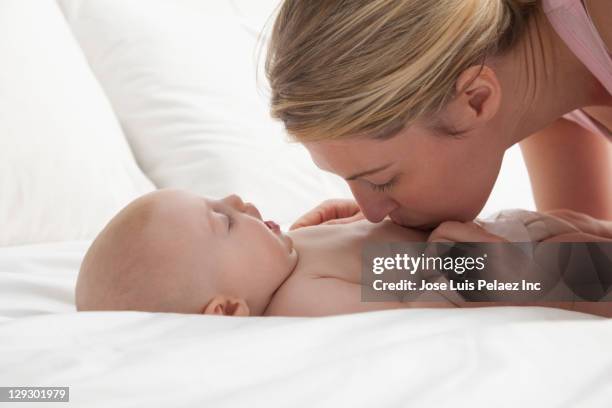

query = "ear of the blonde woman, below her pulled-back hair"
[437,65,502,135]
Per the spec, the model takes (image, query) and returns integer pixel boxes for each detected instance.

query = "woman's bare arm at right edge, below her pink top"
[521,119,612,220]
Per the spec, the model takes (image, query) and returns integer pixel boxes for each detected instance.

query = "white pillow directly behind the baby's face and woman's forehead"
[58,0,350,225]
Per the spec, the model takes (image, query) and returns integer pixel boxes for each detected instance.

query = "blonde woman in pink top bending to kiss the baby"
[266,0,612,241]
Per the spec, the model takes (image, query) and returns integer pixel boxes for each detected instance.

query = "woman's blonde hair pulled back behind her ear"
[266,0,536,142]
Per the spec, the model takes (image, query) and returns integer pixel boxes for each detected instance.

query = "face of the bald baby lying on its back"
[190,191,297,314]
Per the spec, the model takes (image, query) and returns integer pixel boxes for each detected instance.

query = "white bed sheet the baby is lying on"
[0,242,612,407]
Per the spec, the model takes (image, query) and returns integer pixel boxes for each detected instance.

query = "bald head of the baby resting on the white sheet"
[76,190,297,316]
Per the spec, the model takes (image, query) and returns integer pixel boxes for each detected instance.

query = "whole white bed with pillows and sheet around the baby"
[0,0,612,407]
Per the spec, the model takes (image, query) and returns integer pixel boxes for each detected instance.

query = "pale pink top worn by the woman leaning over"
[542,0,612,139]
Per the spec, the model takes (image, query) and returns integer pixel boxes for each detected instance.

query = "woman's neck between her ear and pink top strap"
[491,5,612,146]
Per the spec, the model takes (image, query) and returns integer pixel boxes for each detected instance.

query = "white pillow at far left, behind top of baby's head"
[0,0,153,245]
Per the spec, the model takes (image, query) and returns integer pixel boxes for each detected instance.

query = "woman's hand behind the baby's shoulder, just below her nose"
[290,199,365,230]
